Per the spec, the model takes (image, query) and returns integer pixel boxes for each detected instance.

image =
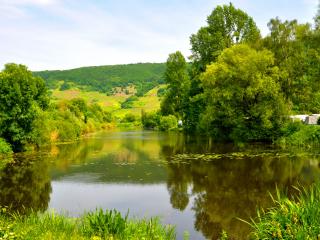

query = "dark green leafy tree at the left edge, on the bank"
[0,64,49,151]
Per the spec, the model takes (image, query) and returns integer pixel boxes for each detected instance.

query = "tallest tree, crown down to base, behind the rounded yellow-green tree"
[184,3,260,132]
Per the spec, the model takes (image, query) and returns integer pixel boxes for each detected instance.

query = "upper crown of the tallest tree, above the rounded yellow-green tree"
[190,3,260,72]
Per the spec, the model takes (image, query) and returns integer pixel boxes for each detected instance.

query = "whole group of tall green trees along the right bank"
[161,3,320,144]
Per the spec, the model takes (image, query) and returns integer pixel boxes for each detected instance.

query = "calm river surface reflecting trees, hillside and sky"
[0,131,320,239]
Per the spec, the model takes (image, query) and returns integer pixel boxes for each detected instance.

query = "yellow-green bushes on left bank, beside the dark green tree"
[31,98,113,146]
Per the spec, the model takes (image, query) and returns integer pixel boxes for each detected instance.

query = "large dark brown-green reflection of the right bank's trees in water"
[163,138,320,239]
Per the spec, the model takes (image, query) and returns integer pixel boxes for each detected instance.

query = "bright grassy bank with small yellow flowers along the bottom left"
[0,209,175,240]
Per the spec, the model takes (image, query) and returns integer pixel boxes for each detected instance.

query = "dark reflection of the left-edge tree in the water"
[0,156,51,212]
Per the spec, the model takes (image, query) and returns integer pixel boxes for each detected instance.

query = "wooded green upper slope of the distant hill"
[34,63,165,96]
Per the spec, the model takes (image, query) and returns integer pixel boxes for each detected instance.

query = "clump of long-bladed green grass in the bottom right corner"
[251,183,320,239]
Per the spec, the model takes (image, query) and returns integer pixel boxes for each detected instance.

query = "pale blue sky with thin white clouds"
[0,0,319,71]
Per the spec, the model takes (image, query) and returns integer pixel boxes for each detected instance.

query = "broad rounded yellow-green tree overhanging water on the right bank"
[200,44,287,142]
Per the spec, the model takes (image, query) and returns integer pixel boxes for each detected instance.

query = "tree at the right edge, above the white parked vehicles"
[263,18,320,112]
